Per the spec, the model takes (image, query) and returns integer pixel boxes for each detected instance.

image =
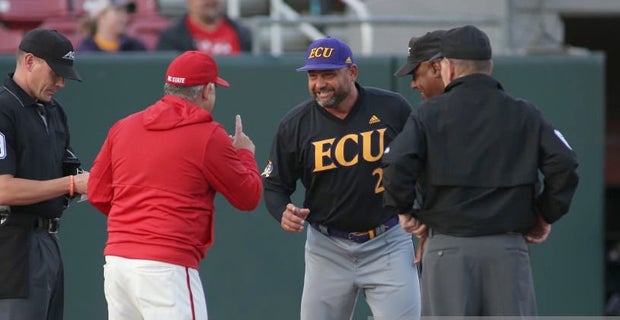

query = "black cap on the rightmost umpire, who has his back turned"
[429,25,491,60]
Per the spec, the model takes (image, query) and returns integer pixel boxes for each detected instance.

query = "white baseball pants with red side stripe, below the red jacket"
[103,256,208,320]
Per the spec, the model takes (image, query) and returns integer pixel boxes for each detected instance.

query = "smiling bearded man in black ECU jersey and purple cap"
[263,37,420,320]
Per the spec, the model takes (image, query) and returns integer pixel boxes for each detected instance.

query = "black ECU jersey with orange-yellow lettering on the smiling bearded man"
[263,83,411,232]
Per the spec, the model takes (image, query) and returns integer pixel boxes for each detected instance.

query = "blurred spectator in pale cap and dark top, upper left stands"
[77,0,147,52]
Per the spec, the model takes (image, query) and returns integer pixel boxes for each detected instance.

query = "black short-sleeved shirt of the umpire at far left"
[0,76,70,218]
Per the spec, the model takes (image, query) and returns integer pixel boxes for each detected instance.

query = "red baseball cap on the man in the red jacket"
[166,51,230,87]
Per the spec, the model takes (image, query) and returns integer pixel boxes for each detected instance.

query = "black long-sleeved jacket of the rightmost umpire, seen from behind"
[383,74,578,236]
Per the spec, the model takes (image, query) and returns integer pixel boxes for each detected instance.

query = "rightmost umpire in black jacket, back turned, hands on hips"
[382,26,578,316]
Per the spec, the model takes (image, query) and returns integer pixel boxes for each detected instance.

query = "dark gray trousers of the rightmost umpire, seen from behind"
[422,234,537,316]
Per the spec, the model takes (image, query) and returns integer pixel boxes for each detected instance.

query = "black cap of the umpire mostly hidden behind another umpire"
[394,30,446,77]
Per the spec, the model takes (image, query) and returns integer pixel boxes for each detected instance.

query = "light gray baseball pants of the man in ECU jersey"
[301,225,420,320]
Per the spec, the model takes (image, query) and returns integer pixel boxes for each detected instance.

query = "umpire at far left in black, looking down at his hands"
[0,29,88,320]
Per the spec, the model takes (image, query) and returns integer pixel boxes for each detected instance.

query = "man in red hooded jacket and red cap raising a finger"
[88,51,262,319]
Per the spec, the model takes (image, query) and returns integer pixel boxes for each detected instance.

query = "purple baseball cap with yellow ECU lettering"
[297,37,354,71]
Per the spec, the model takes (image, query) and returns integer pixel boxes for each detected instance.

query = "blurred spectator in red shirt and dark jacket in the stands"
[157,0,252,55]
